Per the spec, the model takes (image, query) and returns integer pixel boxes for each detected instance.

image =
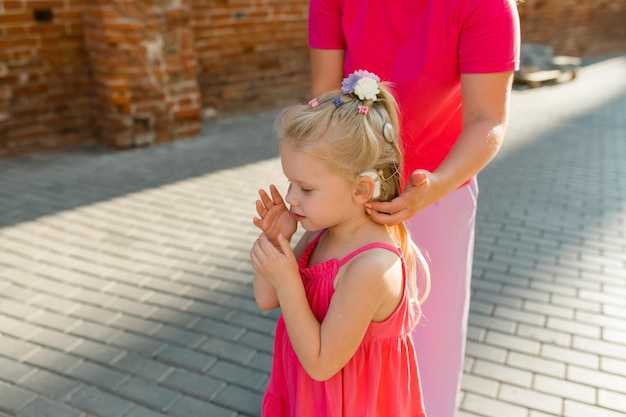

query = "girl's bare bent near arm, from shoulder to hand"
[253,234,403,381]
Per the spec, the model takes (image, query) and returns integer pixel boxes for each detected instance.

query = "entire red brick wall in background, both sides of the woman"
[0,0,626,157]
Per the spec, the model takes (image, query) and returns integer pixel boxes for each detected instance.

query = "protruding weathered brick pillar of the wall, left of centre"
[83,0,202,148]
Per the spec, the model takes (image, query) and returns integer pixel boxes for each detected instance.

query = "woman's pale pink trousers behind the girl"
[406,179,478,417]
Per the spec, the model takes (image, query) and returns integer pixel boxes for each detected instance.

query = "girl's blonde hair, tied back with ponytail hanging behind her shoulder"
[276,83,430,324]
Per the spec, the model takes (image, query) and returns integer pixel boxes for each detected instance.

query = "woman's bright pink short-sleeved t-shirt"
[309,0,520,179]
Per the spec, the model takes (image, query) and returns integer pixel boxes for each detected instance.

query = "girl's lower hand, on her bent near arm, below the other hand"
[250,234,302,291]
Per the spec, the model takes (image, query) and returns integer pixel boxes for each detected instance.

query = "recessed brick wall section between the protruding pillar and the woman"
[193,0,309,113]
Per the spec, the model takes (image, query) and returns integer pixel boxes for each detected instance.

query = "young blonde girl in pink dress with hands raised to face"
[250,70,429,417]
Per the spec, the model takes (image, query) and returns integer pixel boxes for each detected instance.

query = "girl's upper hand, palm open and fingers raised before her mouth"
[252,184,298,248]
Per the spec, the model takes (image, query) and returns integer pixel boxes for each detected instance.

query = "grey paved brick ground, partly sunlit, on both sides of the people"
[0,52,626,417]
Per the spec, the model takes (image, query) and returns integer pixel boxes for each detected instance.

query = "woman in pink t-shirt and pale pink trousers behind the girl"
[309,0,520,417]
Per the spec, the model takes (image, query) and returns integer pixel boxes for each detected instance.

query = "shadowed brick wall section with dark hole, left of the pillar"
[0,0,93,156]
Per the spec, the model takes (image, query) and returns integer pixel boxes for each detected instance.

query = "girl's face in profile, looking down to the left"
[280,143,363,231]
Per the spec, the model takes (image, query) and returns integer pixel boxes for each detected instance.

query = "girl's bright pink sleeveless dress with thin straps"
[261,234,425,417]
